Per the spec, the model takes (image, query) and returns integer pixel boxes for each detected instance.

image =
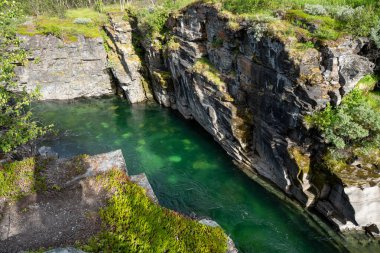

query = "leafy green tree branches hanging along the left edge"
[0,0,46,153]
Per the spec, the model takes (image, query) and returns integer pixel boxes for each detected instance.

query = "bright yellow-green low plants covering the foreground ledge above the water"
[83,170,227,253]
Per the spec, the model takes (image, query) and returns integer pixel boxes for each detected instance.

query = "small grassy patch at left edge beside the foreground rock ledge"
[0,158,46,200]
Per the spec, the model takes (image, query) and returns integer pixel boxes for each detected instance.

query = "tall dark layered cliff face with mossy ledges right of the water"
[136,4,380,232]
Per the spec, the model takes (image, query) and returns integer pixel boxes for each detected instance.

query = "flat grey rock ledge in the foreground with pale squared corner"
[0,150,127,253]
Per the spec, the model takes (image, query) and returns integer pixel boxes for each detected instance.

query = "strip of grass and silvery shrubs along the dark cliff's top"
[217,0,380,40]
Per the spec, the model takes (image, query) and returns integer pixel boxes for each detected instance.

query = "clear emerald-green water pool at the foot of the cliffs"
[34,98,341,253]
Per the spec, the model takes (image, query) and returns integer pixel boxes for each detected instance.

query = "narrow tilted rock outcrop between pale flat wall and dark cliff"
[105,13,151,103]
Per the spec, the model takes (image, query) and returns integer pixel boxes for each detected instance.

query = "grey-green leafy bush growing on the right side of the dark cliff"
[307,89,380,149]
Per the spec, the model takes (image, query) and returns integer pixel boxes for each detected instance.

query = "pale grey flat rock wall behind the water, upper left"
[16,35,113,99]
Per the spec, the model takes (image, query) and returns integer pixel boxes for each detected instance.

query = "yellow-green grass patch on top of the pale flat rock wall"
[17,8,107,41]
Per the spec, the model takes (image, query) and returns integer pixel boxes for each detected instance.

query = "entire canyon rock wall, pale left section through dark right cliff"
[16,3,380,241]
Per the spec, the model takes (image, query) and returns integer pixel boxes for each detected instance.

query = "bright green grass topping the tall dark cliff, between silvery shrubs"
[212,0,380,40]
